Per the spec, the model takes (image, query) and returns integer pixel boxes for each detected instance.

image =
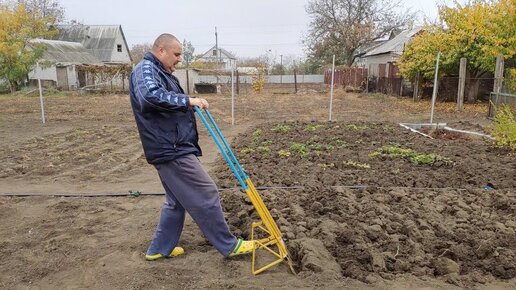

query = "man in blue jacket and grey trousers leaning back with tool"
[129,34,255,261]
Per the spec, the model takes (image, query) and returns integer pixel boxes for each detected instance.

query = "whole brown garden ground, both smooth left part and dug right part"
[0,90,516,289]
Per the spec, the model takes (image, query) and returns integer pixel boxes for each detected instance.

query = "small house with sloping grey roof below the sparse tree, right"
[360,27,421,78]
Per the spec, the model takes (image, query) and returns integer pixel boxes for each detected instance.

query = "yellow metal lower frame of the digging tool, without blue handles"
[245,179,296,275]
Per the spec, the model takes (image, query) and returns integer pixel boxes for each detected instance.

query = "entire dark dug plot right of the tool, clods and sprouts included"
[212,122,516,287]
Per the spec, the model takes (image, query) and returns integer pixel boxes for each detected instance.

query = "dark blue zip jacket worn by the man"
[129,52,202,164]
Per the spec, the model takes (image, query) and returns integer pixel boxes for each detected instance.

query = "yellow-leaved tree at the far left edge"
[0,4,55,92]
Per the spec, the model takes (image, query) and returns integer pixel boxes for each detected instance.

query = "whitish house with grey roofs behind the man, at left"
[29,24,132,90]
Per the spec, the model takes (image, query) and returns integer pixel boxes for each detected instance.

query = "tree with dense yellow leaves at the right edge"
[398,0,516,102]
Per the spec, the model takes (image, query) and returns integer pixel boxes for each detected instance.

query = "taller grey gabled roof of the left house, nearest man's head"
[55,24,130,62]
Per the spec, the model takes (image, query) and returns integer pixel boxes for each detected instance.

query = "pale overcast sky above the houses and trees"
[59,0,463,58]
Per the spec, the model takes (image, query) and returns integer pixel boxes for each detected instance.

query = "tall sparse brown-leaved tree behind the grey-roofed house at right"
[304,0,415,65]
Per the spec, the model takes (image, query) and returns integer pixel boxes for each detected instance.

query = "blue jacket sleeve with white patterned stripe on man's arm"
[131,62,190,112]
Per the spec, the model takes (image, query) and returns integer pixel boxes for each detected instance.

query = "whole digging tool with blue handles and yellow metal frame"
[195,107,296,275]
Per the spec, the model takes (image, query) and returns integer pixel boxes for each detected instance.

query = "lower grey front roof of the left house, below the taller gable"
[32,39,102,64]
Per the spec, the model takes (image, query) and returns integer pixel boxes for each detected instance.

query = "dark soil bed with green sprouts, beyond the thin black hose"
[213,122,516,189]
